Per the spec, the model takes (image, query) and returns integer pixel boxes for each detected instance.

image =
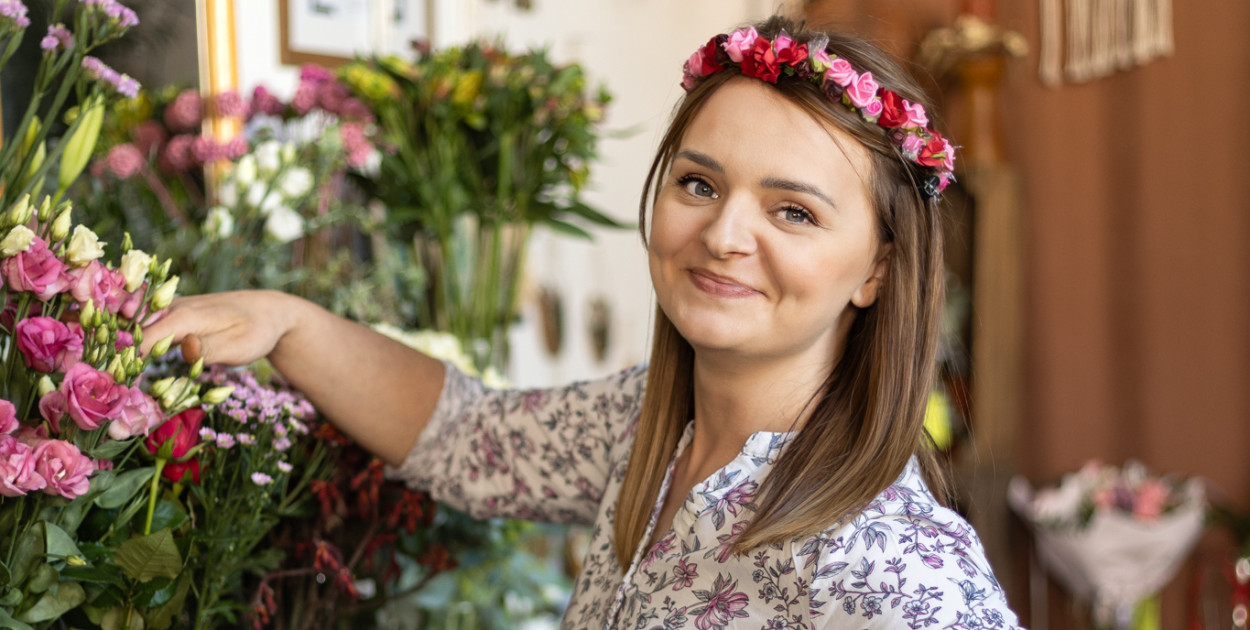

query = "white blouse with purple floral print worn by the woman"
[390,365,1018,630]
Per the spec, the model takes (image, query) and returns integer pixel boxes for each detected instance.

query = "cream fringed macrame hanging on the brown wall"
[1039,0,1173,88]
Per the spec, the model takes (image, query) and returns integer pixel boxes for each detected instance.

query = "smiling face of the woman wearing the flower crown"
[649,79,888,368]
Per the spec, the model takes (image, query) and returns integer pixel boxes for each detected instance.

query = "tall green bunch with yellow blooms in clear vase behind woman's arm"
[340,43,618,368]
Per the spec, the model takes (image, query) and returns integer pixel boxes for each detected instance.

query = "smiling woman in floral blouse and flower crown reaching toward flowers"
[145,19,1016,630]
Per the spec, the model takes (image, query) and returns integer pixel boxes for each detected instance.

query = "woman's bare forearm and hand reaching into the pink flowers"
[141,291,444,464]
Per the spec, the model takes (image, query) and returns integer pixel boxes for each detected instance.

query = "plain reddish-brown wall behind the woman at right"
[806,0,1250,628]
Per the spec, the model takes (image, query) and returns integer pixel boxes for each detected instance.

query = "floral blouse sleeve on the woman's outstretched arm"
[388,364,646,524]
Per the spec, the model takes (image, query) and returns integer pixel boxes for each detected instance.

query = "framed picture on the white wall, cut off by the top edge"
[278,0,434,68]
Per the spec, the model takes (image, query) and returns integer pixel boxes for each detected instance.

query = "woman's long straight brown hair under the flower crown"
[615,18,946,570]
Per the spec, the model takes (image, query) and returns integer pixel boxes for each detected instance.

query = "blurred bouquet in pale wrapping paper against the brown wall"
[1008,461,1206,628]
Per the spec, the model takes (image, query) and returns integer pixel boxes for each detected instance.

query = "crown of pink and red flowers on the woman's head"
[681,26,955,198]
